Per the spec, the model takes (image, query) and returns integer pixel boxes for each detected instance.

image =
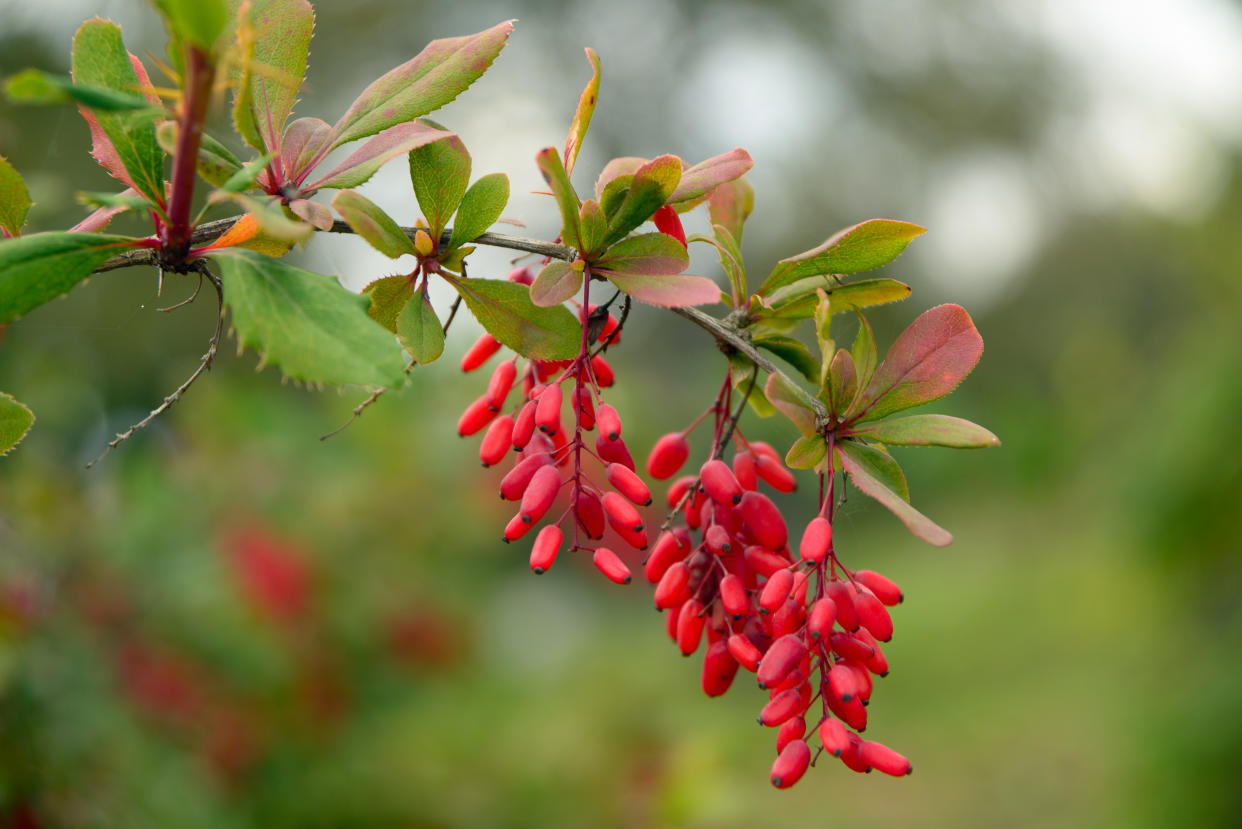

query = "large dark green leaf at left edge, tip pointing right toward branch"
[0,232,134,323]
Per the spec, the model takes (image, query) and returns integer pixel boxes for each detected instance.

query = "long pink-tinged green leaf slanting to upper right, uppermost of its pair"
[329,21,513,147]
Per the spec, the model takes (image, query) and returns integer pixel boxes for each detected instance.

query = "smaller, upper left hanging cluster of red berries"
[457,268,651,584]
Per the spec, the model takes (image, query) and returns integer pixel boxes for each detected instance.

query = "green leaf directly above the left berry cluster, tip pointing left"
[441,273,582,360]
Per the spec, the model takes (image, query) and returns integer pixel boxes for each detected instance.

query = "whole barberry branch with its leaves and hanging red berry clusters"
[0,8,999,788]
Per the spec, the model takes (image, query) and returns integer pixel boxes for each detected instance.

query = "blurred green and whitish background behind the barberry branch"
[0,0,1242,827]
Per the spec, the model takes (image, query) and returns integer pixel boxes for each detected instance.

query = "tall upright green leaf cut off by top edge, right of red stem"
[233,0,314,154]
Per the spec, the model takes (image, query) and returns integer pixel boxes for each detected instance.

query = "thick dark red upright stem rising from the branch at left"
[160,46,215,267]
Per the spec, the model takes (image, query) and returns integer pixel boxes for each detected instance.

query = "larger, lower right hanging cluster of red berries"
[643,433,910,788]
